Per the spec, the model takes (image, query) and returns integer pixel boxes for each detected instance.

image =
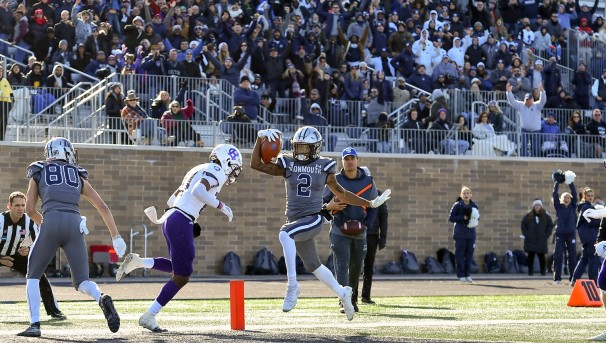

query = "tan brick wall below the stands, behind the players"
[0,143,606,276]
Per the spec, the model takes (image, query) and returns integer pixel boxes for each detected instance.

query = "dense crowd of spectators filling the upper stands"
[0,0,606,157]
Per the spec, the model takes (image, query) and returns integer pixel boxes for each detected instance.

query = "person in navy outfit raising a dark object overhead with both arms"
[552,182,578,284]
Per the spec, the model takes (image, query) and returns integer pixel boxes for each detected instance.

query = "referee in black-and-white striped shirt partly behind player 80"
[0,192,66,320]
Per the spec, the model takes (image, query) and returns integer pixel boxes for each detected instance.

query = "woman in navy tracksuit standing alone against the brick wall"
[448,186,479,282]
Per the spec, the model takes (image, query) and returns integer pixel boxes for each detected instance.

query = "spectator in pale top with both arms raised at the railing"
[506,82,547,156]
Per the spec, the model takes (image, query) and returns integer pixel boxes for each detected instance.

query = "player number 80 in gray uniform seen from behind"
[18,137,126,337]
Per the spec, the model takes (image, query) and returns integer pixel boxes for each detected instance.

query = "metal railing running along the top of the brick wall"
[9,114,606,158]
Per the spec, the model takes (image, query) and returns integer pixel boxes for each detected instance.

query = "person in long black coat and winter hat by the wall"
[520,198,554,275]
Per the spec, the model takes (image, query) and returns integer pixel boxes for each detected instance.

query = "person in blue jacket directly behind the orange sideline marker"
[570,187,600,286]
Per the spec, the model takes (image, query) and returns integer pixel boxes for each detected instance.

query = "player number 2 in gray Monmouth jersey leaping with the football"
[250,126,391,320]
